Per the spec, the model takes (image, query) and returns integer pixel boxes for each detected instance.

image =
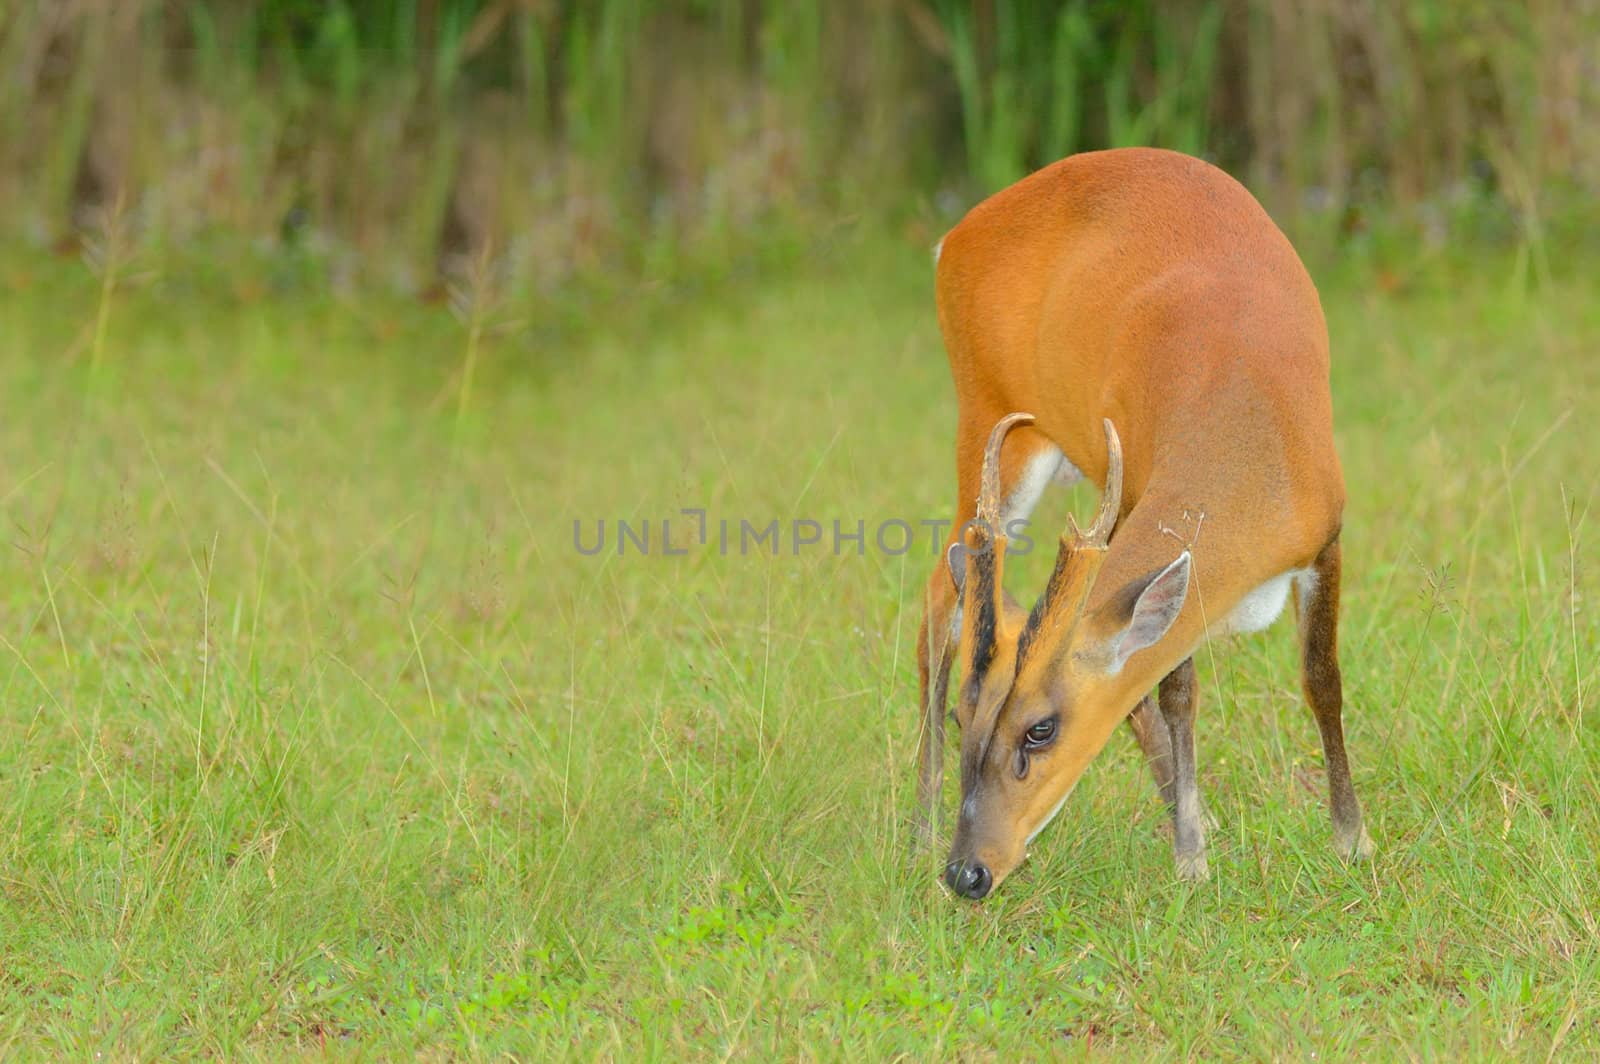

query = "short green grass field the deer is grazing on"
[0,237,1600,1059]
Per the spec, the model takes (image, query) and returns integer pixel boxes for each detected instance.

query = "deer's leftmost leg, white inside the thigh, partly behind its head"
[915,410,1077,845]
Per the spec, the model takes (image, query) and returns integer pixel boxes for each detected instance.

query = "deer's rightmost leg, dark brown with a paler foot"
[1294,539,1373,861]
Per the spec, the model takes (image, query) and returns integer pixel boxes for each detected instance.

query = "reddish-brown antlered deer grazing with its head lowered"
[917,149,1373,901]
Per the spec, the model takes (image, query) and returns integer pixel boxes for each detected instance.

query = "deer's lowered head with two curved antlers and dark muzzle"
[944,414,1190,899]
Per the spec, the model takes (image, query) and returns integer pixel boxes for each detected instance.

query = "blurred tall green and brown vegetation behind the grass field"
[0,0,1600,293]
